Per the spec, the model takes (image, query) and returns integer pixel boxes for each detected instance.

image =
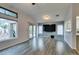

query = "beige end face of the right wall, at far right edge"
[72,3,79,49]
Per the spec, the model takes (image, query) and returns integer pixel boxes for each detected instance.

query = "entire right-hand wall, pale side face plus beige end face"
[64,4,76,49]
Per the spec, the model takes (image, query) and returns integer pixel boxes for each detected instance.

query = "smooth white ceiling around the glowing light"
[11,3,70,23]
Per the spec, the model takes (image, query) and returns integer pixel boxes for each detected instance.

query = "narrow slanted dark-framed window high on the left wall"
[0,7,18,18]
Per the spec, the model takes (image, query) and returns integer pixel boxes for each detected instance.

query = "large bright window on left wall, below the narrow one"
[0,18,17,41]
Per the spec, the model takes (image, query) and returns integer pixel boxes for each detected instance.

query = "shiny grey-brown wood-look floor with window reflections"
[0,37,76,55]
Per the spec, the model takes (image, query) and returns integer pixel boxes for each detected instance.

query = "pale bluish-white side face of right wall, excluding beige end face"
[64,4,72,48]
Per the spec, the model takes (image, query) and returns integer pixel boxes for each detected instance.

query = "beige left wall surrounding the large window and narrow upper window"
[0,4,35,50]
